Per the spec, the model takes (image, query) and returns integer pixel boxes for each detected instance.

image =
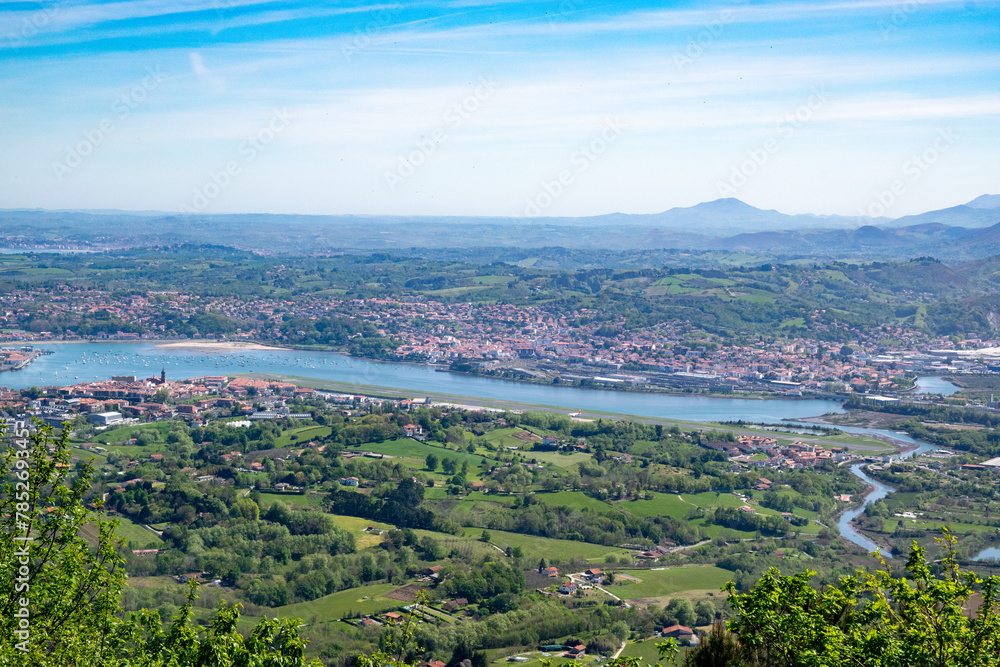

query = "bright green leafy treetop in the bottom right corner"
[727,530,1000,667]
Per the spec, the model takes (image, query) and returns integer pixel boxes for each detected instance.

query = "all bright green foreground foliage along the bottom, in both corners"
[0,427,1000,667]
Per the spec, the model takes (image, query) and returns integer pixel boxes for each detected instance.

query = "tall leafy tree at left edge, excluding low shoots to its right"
[0,422,125,665]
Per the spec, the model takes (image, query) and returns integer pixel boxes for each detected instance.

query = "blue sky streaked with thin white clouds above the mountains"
[0,0,1000,218]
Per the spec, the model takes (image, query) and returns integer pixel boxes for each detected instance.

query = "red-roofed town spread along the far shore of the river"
[0,287,1000,396]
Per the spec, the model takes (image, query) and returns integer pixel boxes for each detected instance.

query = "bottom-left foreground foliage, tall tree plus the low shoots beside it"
[0,423,321,667]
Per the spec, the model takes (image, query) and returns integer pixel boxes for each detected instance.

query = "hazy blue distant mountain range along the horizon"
[0,195,1000,261]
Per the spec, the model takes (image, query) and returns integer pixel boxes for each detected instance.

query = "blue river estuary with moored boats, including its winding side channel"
[0,343,976,557]
